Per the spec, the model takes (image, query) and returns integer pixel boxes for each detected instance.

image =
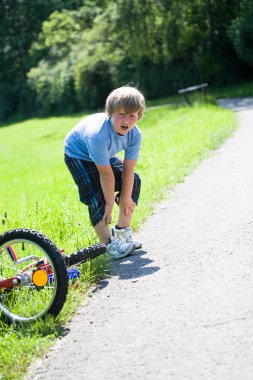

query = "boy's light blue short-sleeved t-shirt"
[64,113,141,165]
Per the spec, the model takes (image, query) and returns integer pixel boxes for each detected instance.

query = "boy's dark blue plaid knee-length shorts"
[64,154,141,226]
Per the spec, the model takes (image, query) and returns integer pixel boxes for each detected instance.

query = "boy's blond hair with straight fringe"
[105,86,145,119]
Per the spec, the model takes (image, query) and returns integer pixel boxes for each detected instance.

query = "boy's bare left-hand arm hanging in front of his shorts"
[95,164,115,224]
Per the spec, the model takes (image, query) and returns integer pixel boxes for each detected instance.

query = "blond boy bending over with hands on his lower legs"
[64,86,145,259]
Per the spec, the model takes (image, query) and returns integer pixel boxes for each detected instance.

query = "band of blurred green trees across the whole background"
[0,0,252,118]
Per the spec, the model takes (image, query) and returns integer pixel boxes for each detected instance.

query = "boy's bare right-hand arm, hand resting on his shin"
[120,159,136,215]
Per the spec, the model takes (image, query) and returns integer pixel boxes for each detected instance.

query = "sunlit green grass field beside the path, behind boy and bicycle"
[0,105,236,379]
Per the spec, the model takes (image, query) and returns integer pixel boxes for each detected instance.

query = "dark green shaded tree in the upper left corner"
[0,0,83,118]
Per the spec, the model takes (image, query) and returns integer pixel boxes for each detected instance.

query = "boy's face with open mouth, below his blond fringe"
[110,109,139,136]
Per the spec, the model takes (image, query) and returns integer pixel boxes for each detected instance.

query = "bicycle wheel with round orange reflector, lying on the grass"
[0,229,68,322]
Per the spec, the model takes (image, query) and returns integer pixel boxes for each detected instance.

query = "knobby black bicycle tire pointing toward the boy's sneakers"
[63,243,106,267]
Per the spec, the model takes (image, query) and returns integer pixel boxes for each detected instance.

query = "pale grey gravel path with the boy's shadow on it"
[27,100,253,380]
